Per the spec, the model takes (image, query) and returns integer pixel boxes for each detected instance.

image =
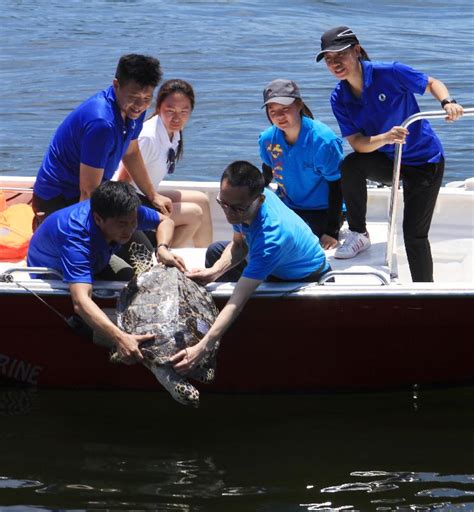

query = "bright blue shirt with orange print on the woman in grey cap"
[259,116,343,210]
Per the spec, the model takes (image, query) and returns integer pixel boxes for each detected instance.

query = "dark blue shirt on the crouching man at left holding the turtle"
[27,199,160,284]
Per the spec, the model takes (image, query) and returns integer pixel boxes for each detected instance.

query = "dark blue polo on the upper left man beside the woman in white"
[34,86,146,199]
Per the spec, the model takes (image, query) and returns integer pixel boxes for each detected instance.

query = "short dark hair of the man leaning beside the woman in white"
[115,53,162,87]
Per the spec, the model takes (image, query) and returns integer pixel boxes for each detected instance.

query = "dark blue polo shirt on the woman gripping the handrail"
[331,61,443,166]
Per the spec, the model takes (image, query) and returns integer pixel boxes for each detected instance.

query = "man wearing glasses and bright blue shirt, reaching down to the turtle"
[171,161,331,375]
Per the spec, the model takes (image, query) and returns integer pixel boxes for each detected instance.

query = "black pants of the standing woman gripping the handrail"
[341,151,444,282]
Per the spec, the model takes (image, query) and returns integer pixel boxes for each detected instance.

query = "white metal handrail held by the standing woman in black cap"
[385,108,474,275]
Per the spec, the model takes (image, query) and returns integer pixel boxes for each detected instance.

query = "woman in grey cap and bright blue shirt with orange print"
[259,79,343,249]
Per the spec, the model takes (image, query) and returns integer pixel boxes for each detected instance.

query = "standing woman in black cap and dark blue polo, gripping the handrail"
[316,27,463,282]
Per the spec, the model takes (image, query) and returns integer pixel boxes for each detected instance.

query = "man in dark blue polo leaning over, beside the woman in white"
[32,54,171,225]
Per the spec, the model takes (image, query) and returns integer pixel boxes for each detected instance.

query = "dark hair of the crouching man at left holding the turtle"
[91,181,141,220]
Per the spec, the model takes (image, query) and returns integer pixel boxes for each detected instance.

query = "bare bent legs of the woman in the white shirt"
[158,190,213,247]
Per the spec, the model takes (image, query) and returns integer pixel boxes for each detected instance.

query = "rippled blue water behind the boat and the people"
[0,0,474,182]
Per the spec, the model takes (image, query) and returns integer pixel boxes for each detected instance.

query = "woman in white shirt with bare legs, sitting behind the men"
[117,79,212,247]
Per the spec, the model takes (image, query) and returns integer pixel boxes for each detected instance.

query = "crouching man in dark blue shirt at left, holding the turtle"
[28,181,185,363]
